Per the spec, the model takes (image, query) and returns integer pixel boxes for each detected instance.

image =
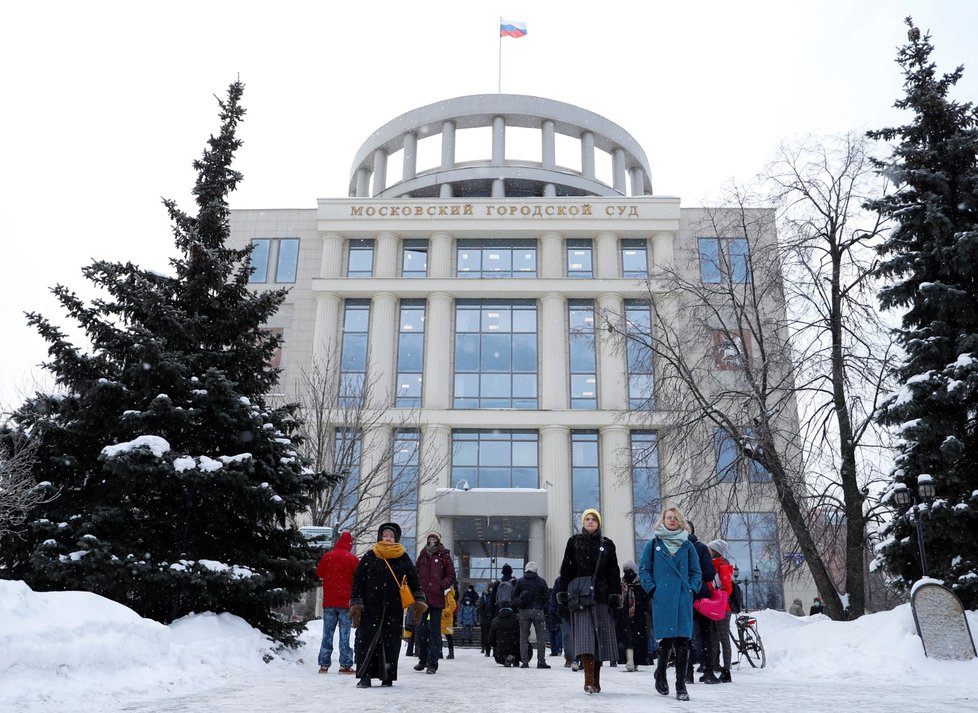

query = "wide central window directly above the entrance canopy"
[452,431,540,488]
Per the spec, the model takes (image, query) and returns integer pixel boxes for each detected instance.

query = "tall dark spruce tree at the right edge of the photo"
[869,18,978,609]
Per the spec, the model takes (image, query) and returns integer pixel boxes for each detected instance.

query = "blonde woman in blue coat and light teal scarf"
[638,508,702,701]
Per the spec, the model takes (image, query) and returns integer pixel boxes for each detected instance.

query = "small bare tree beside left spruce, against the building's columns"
[295,354,448,539]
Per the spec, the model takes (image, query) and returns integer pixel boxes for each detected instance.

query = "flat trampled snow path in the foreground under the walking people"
[51,649,960,713]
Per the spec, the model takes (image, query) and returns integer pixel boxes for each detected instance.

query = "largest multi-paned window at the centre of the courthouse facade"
[453,300,537,409]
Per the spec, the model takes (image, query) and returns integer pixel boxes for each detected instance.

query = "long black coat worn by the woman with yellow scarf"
[350,550,424,681]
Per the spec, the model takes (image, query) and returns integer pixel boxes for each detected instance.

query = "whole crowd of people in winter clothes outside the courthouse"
[317,508,768,701]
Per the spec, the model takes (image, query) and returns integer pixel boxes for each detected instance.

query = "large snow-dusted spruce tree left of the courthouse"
[0,82,315,644]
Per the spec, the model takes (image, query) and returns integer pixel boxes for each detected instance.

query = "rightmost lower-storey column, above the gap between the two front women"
[598,424,637,567]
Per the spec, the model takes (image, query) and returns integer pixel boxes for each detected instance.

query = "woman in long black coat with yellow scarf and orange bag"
[350,522,428,688]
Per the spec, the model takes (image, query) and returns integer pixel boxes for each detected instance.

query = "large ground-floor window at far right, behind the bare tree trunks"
[720,512,784,609]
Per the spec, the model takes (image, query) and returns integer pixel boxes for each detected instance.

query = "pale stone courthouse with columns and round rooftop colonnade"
[231,94,804,606]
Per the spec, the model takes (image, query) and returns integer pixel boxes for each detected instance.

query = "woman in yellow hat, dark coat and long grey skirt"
[557,508,621,693]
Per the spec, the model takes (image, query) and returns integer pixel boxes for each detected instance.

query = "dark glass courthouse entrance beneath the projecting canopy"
[453,515,530,592]
